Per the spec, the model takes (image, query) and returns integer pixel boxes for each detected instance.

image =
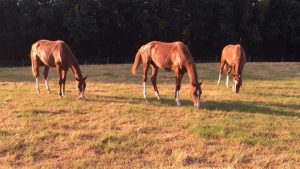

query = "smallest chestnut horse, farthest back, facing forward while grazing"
[218,44,246,93]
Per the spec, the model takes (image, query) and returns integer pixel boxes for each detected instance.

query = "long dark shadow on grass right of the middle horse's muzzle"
[202,101,300,117]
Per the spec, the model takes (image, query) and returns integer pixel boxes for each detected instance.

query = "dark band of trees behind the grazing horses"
[0,0,300,66]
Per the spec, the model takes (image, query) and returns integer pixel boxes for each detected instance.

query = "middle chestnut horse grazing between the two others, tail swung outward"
[132,41,202,108]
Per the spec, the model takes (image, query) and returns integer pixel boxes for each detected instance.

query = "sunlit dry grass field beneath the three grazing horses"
[0,63,300,168]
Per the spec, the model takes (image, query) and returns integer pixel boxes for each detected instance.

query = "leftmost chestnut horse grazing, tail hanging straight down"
[30,40,87,99]
